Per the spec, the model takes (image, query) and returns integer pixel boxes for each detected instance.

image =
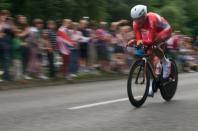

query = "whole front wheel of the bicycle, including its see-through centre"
[127,60,150,107]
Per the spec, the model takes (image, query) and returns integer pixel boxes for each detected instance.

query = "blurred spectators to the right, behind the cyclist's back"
[167,31,198,72]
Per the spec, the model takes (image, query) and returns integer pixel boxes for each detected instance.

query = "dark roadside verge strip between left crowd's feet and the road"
[0,74,127,91]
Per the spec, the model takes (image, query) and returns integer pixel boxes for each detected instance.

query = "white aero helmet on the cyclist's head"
[131,5,147,19]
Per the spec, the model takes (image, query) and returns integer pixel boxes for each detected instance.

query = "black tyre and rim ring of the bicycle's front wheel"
[127,60,150,108]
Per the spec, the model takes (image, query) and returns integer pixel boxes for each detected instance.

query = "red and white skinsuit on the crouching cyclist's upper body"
[133,12,172,45]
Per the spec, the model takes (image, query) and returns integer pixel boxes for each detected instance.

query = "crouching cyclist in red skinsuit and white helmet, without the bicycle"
[128,5,172,96]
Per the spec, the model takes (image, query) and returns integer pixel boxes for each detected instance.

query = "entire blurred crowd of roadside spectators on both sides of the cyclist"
[0,10,198,81]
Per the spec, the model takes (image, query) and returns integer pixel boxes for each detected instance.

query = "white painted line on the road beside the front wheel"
[67,96,142,110]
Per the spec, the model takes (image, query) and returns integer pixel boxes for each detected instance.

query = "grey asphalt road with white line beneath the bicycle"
[0,73,198,131]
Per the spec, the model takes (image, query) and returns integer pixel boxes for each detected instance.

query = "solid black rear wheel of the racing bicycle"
[160,59,178,101]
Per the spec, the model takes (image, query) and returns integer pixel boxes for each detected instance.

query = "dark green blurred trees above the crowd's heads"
[0,0,198,34]
